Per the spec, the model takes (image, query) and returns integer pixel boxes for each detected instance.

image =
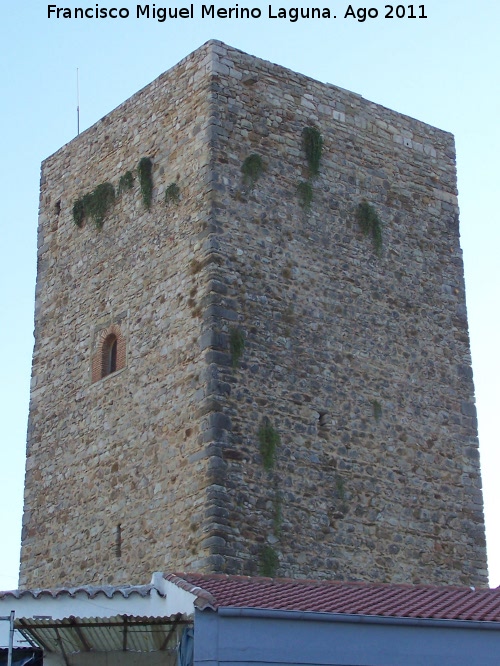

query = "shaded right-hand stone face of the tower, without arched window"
[200,44,487,585]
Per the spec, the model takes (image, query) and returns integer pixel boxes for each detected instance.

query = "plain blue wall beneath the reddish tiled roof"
[195,611,500,666]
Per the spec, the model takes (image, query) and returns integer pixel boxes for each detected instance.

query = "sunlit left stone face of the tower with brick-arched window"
[20,42,219,587]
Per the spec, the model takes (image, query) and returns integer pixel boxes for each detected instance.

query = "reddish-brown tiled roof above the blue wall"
[165,573,500,622]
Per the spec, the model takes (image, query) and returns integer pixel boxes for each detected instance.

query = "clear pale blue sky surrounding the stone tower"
[0,0,500,590]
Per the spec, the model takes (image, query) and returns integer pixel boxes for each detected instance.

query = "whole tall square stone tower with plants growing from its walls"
[20,41,487,587]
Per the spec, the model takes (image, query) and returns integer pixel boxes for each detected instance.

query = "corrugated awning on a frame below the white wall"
[15,613,192,663]
